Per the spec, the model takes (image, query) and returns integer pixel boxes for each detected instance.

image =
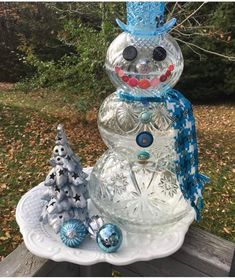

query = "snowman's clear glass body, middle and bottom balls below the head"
[89,93,189,232]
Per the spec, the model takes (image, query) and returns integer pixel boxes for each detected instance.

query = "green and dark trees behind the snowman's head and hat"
[0,2,235,110]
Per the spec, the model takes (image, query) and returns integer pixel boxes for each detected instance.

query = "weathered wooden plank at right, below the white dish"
[171,227,235,276]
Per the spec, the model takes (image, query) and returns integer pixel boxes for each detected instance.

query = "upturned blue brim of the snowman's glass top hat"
[116,18,176,36]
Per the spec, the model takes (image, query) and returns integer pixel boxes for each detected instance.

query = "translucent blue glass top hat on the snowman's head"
[116,2,176,36]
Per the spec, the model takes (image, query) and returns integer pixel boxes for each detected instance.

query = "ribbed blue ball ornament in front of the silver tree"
[60,219,88,248]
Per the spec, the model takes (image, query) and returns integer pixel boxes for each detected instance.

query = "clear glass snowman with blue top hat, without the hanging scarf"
[88,2,207,233]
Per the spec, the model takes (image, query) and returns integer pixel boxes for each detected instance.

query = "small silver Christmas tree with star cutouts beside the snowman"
[40,124,88,233]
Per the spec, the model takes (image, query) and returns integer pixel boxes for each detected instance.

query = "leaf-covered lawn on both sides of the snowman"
[0,87,235,260]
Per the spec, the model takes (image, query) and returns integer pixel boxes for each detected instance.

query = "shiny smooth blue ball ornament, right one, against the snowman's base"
[96,223,123,253]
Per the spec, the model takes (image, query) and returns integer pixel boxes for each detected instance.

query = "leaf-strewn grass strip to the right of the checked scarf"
[195,104,235,238]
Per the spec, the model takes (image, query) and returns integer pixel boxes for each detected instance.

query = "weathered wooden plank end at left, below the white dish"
[0,243,47,277]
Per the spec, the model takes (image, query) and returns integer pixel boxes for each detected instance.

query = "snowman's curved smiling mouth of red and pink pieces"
[114,64,174,89]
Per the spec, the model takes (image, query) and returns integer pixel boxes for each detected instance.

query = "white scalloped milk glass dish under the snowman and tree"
[16,168,194,265]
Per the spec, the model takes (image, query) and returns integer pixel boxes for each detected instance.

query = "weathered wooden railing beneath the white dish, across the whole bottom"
[0,227,235,277]
